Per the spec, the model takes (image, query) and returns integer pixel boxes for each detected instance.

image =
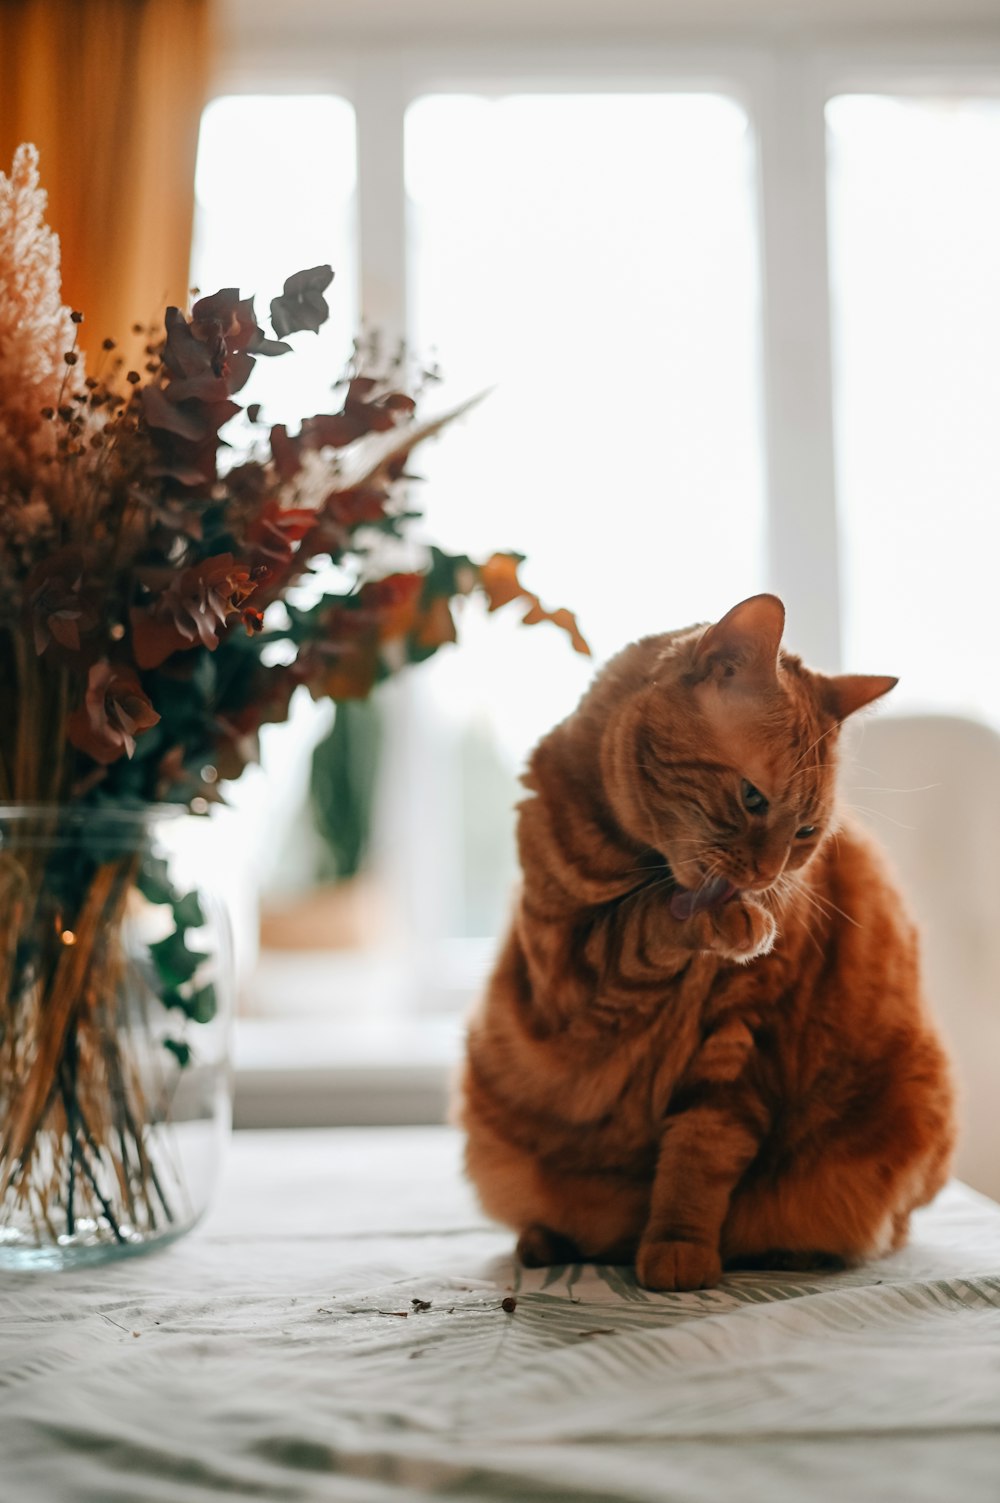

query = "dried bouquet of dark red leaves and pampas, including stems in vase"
[0,146,586,1247]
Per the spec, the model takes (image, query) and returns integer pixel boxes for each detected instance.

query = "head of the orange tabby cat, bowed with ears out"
[601,595,895,917]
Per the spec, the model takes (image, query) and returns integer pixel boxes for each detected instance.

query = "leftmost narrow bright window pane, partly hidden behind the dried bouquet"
[191,95,358,1007]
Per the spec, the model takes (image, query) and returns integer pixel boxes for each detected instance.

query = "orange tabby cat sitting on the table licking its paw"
[459,595,953,1290]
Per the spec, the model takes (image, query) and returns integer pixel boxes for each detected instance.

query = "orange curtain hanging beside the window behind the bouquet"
[0,0,212,352]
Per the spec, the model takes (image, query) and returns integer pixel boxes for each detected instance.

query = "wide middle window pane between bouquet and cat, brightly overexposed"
[406,95,764,933]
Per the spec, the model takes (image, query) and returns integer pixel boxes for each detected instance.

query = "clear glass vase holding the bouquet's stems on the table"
[0,806,233,1269]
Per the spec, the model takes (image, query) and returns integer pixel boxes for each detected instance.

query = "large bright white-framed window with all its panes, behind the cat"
[198,17,1000,1120]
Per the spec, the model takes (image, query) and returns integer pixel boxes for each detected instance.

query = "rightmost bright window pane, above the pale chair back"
[827,95,1000,721]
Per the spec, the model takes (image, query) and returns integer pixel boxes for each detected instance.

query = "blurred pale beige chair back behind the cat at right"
[842,712,1000,1199]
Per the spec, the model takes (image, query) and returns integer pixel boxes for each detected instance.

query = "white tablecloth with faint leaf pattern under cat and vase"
[0,1129,1000,1503]
